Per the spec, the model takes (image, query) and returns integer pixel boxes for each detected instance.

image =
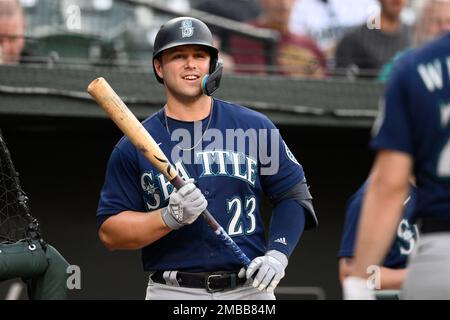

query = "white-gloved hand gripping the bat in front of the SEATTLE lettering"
[161,179,208,229]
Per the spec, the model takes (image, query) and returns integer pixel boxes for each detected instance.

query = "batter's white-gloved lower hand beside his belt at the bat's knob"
[238,250,288,292]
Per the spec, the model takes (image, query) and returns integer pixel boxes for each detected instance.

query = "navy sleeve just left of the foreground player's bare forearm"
[338,190,363,258]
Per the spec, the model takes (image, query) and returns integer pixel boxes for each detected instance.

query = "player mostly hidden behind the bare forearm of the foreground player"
[338,180,418,290]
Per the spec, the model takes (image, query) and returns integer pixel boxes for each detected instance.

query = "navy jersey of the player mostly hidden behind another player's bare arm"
[338,180,418,269]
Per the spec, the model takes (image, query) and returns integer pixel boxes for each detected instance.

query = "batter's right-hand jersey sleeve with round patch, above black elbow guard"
[260,120,305,198]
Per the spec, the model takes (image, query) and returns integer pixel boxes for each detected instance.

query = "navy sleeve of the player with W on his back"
[371,55,413,155]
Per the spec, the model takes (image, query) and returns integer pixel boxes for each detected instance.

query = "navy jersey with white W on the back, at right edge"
[372,34,450,219]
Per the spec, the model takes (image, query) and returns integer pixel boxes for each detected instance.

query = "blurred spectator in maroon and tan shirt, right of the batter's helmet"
[230,0,326,77]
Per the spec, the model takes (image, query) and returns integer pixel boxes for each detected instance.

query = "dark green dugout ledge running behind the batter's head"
[0,64,383,127]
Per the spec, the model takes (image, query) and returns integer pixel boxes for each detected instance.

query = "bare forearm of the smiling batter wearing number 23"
[99,210,172,250]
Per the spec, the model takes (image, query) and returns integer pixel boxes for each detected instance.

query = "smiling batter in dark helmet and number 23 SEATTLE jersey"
[97,17,317,300]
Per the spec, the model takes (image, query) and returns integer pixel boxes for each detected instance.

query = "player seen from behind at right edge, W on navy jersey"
[343,33,450,299]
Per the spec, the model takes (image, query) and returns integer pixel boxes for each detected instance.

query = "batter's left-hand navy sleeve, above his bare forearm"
[97,147,144,228]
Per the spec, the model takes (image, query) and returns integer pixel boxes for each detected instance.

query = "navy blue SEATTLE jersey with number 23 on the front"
[97,99,304,272]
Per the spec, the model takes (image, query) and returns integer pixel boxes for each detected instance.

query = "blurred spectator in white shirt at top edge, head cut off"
[289,0,379,58]
